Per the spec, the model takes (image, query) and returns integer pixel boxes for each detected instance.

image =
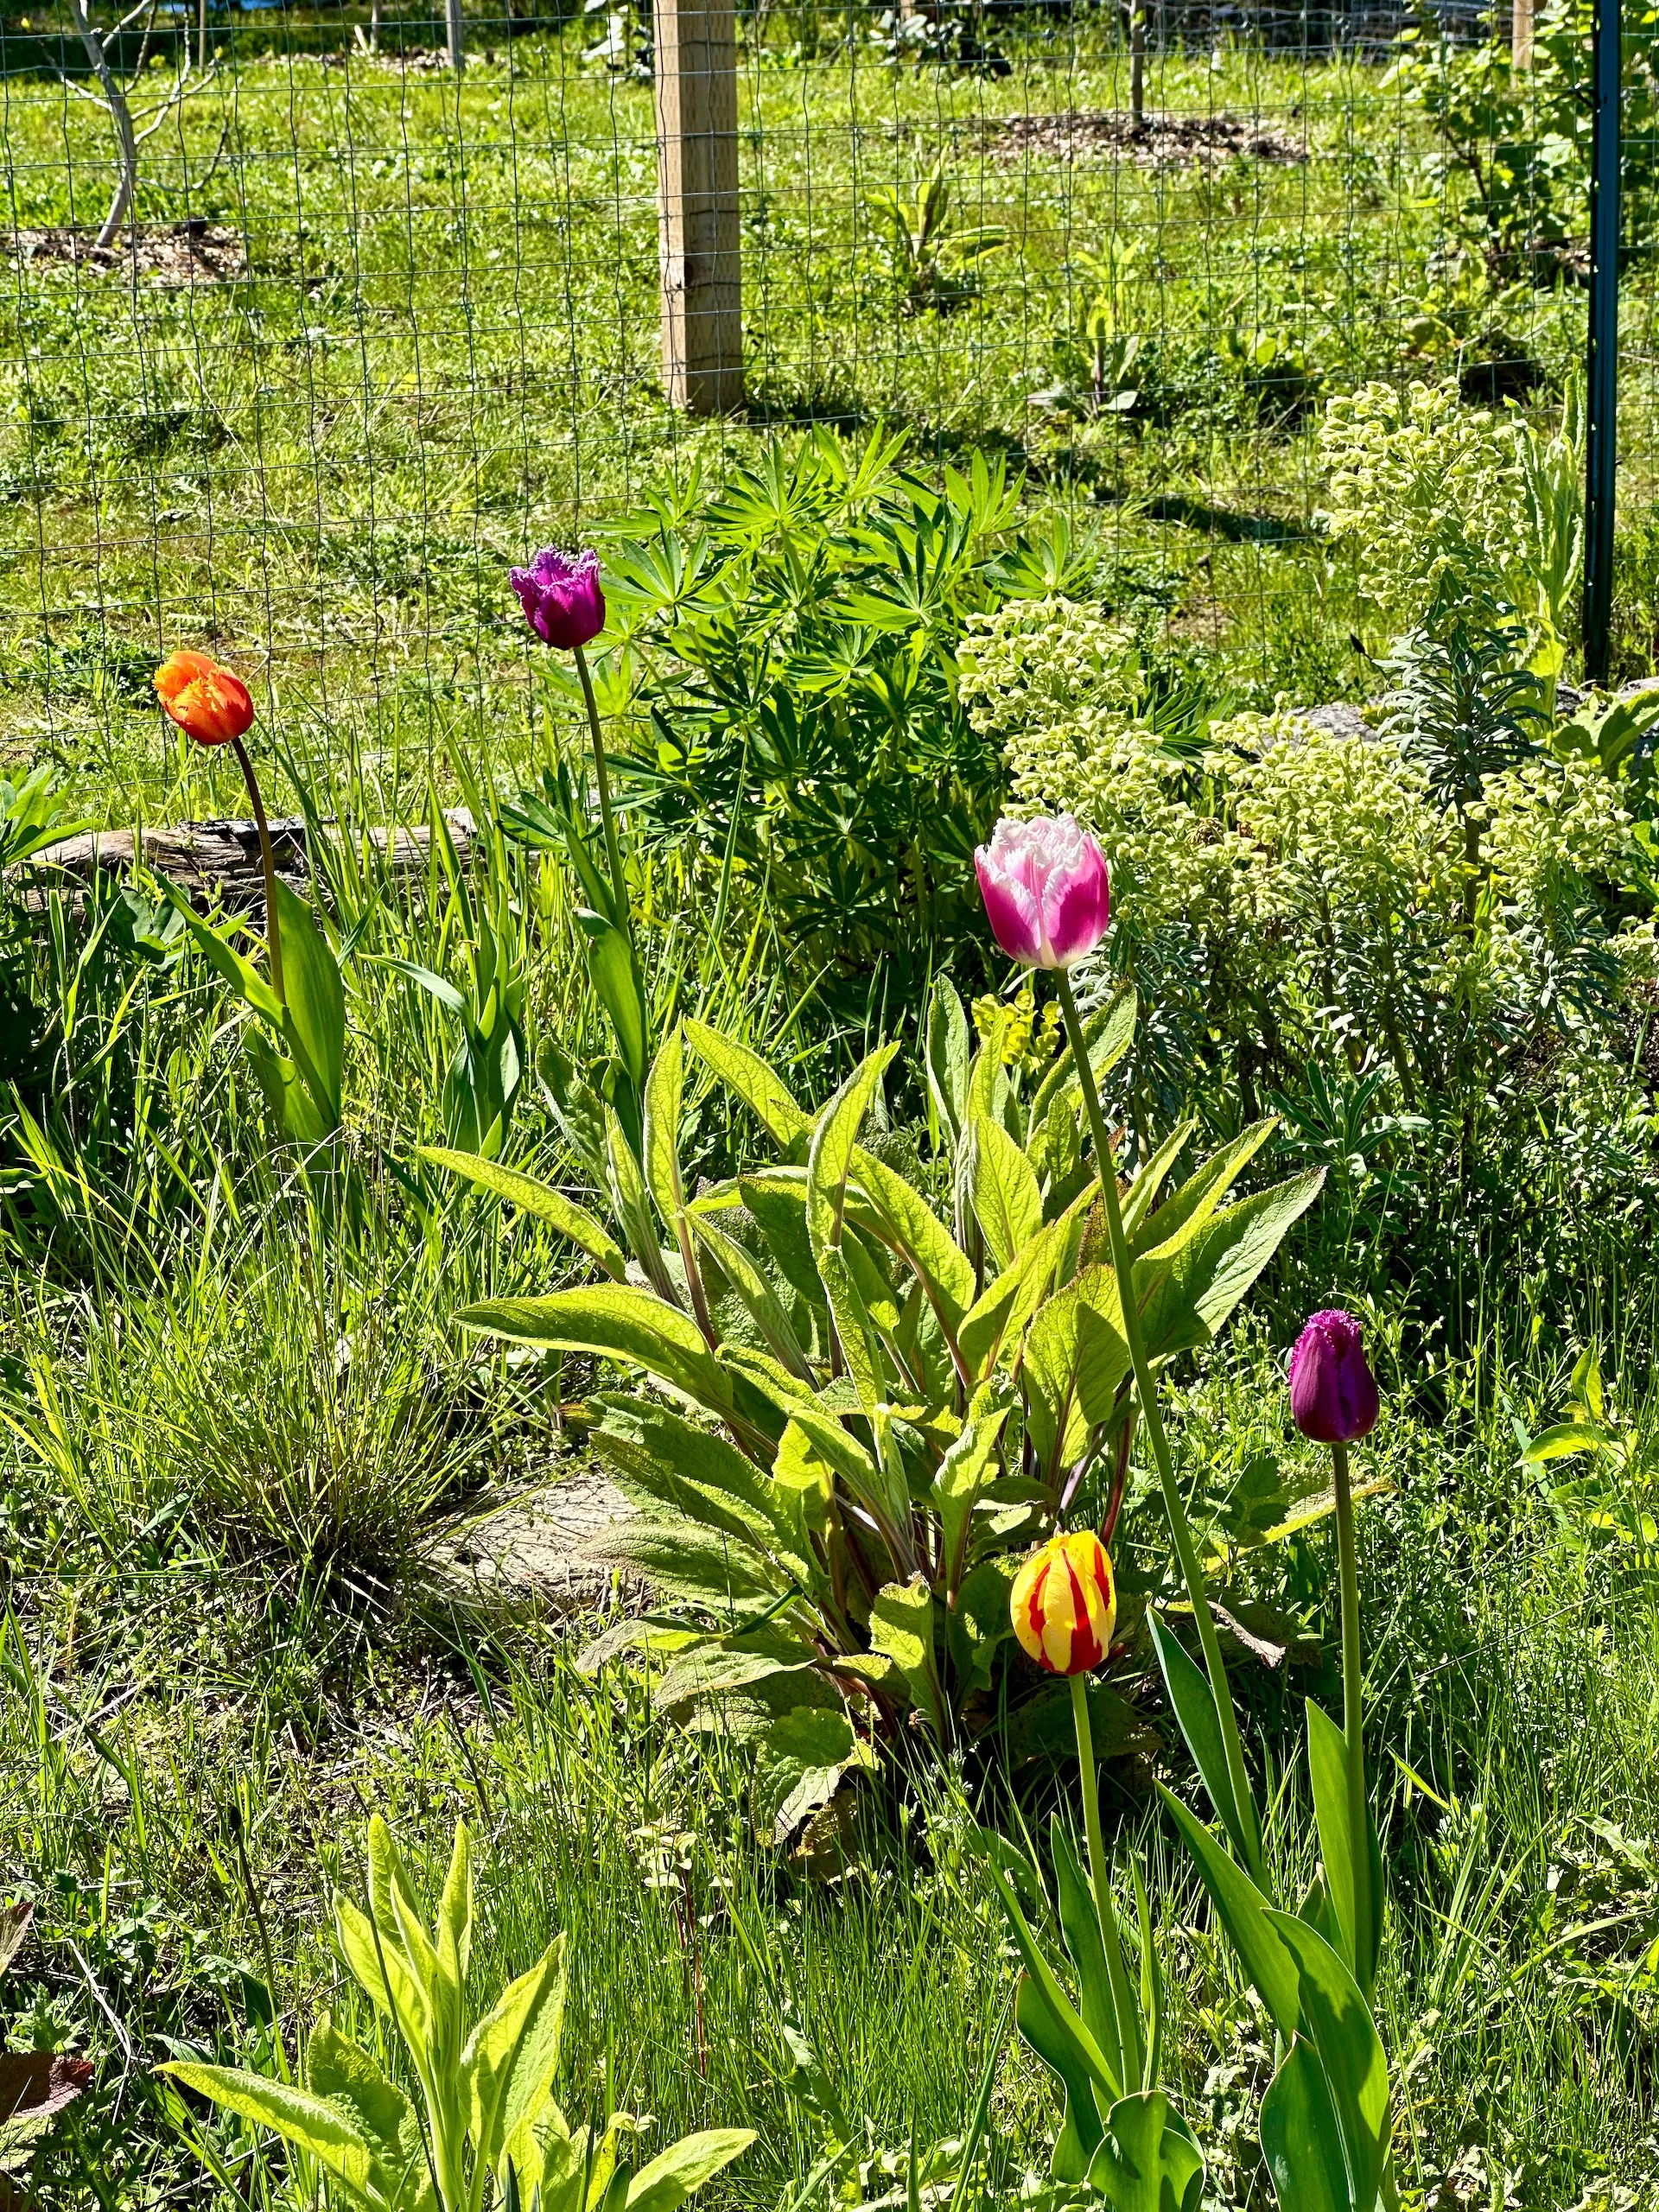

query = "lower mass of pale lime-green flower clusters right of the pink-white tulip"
[964,600,1652,1110]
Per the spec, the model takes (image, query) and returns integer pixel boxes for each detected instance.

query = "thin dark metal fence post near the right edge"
[1584,0,1621,683]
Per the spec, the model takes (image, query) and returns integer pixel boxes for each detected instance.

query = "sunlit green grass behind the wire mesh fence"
[0,10,1581,818]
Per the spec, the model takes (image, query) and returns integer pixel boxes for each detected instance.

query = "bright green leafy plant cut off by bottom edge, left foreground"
[159,1816,754,2212]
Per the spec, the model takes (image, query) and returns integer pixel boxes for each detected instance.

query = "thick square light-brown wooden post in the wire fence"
[652,0,743,416]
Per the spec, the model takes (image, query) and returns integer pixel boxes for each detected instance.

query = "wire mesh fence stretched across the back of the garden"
[0,0,1652,809]
